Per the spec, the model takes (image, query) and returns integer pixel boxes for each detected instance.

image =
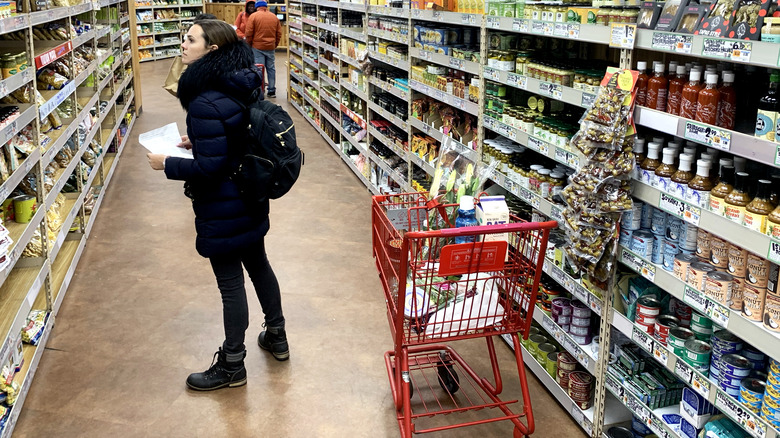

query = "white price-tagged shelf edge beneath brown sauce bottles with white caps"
[632,180,780,262]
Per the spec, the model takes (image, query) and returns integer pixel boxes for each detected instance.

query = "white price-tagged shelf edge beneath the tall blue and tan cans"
[618,246,780,359]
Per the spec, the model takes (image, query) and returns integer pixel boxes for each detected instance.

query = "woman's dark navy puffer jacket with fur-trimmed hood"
[165,42,269,257]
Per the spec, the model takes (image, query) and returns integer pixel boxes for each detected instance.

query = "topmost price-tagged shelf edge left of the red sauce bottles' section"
[485,17,610,44]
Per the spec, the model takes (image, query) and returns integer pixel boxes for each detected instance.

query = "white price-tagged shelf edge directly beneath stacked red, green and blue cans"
[612,309,776,438]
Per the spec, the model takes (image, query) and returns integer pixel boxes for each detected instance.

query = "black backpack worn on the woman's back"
[233,93,303,206]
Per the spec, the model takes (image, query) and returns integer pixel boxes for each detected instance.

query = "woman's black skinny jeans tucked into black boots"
[209,240,284,354]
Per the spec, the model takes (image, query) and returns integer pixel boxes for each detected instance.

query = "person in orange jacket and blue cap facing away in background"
[244,0,282,97]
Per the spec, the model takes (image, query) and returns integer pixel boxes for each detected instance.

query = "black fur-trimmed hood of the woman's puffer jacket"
[178,41,263,110]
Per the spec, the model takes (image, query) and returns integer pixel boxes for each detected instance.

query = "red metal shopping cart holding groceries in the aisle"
[372,193,557,438]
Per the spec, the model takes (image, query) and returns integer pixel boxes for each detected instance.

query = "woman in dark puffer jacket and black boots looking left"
[148,20,289,391]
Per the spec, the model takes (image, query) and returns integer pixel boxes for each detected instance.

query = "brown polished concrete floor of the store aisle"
[10,56,583,438]
